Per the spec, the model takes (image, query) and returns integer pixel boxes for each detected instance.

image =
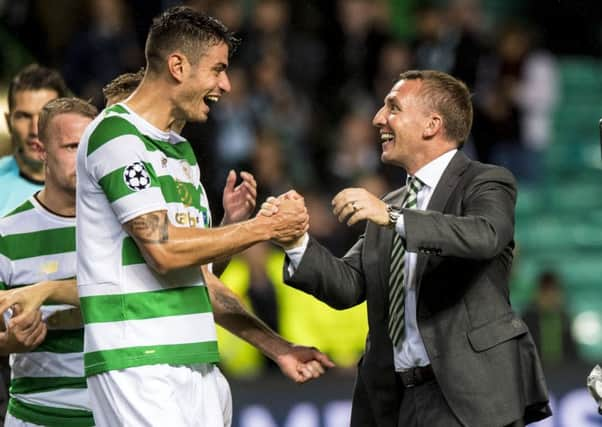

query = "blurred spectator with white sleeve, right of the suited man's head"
[473,22,557,181]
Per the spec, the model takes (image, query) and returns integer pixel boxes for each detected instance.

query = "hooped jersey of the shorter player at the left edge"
[0,196,94,427]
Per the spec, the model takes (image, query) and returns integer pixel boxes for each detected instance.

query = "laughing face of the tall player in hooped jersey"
[180,42,230,122]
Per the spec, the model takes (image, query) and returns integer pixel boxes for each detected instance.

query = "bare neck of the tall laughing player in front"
[125,80,174,131]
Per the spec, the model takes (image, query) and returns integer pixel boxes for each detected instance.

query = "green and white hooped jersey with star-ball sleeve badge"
[77,104,219,376]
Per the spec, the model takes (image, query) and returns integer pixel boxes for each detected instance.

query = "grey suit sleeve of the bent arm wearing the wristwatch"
[403,168,516,260]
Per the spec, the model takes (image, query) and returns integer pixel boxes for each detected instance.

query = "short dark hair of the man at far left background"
[8,64,71,111]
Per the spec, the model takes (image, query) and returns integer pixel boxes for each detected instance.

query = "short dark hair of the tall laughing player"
[144,6,240,72]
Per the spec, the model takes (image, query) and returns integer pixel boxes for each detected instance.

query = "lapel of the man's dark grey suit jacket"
[415,151,470,290]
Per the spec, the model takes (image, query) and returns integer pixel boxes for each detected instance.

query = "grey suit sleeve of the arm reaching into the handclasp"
[284,236,366,310]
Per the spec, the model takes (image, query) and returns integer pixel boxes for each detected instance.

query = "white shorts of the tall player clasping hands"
[88,364,232,427]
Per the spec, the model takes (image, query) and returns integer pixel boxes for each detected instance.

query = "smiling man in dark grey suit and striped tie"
[263,71,551,427]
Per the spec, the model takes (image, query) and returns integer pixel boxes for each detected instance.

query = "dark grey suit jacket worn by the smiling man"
[284,152,551,427]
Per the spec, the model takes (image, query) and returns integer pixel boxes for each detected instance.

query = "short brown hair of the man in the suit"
[399,70,473,145]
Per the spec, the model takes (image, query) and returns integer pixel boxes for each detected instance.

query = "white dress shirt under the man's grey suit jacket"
[286,150,458,371]
